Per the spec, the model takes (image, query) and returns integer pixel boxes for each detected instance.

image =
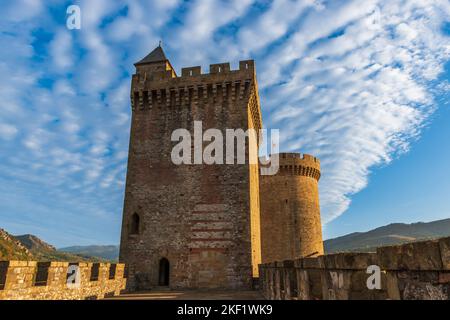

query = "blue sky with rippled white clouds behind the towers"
[0,0,450,246]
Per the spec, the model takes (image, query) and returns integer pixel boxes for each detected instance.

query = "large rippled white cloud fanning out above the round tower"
[262,1,449,222]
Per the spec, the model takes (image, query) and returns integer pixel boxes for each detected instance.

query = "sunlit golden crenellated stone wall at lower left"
[0,261,126,300]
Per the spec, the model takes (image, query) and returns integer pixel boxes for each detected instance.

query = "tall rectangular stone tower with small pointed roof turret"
[120,47,262,290]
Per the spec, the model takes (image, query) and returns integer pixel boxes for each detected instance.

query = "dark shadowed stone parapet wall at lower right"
[260,238,450,300]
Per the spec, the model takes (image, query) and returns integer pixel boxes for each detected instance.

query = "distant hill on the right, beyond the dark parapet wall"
[324,219,450,253]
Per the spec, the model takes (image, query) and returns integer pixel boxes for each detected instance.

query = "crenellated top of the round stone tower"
[261,152,320,181]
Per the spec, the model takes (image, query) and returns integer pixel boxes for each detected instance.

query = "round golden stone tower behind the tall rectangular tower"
[259,153,323,263]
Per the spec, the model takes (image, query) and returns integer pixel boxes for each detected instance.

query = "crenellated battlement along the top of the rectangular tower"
[130,60,262,128]
